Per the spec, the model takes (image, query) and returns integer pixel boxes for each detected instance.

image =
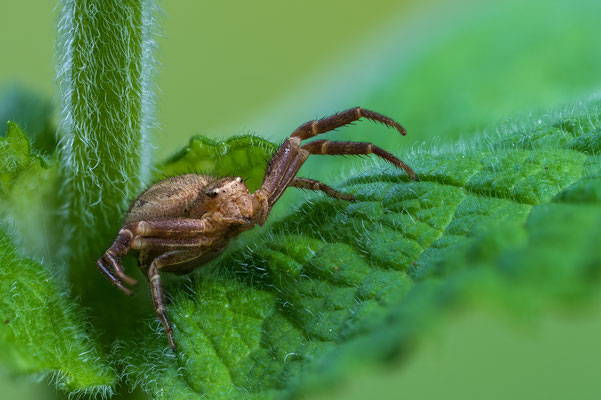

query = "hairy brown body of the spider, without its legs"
[123,174,253,275]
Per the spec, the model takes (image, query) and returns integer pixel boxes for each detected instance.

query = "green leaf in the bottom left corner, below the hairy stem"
[0,231,117,394]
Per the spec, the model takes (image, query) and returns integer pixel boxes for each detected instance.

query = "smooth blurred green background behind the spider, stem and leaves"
[0,0,601,399]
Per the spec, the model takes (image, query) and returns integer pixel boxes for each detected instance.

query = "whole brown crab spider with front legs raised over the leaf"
[97,107,417,351]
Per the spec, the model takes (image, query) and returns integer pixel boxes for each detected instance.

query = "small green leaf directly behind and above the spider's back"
[157,135,277,191]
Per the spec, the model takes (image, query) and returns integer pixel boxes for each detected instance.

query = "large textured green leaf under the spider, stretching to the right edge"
[118,102,601,399]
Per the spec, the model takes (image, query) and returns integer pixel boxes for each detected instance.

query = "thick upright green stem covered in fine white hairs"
[58,0,155,332]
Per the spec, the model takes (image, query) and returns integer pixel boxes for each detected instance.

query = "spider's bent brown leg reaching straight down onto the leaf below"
[147,250,201,351]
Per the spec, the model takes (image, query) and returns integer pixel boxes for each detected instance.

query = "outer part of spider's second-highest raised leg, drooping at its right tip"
[301,140,417,181]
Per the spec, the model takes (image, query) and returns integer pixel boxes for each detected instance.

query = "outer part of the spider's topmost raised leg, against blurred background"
[291,107,407,140]
